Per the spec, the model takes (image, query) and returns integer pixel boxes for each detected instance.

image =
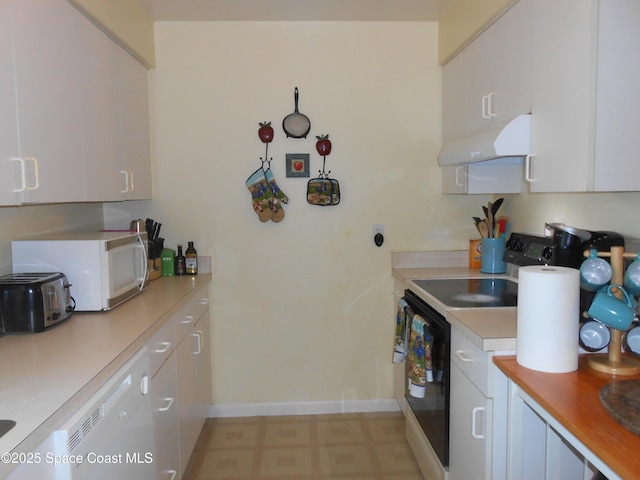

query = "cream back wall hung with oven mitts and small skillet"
[106,22,488,404]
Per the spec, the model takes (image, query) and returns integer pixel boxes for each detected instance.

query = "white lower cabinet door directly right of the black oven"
[449,362,493,480]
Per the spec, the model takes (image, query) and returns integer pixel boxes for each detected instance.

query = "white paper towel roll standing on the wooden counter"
[516,265,580,373]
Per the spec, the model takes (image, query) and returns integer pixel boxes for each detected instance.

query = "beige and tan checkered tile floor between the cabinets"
[184,412,423,480]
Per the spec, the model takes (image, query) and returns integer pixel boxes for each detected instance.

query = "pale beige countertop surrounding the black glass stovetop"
[393,252,517,353]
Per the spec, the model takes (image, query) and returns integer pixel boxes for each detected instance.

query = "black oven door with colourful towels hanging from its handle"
[404,290,451,467]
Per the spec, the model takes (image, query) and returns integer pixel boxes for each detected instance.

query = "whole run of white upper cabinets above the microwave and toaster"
[0,0,151,204]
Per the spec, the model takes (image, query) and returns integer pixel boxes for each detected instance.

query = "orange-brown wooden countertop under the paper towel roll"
[493,355,640,480]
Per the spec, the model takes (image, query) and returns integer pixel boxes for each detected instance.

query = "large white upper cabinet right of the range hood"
[521,0,640,192]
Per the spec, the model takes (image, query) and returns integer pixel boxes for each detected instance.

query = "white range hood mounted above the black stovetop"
[438,114,531,167]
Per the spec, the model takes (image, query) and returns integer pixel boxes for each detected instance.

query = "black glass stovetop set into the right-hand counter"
[413,278,518,308]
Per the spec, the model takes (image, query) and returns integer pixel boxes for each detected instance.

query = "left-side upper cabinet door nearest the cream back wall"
[115,47,152,200]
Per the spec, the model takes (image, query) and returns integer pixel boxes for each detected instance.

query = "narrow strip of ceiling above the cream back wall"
[133,0,449,22]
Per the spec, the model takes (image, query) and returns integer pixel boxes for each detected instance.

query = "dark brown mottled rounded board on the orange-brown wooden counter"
[600,380,640,436]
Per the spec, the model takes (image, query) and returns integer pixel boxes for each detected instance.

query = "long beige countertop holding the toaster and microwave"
[0,274,211,477]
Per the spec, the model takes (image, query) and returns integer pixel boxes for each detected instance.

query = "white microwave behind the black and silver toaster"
[11,232,149,311]
